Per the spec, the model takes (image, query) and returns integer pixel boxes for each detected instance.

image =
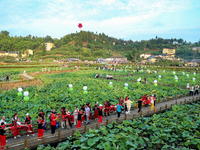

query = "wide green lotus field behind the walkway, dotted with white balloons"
[0,67,200,122]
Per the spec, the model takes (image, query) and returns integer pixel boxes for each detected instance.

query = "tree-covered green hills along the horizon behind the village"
[0,31,200,60]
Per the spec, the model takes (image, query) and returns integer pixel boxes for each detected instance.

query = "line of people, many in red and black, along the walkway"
[0,87,199,146]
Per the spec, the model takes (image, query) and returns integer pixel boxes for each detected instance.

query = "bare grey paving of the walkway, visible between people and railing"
[3,96,198,149]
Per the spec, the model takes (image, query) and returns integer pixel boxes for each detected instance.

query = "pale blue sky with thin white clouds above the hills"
[0,0,200,42]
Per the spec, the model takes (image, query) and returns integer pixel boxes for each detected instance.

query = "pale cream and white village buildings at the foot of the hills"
[0,43,200,66]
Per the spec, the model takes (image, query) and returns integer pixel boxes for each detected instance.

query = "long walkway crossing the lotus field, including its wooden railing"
[3,96,200,150]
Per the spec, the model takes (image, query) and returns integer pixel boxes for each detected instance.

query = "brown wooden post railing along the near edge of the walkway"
[0,97,200,150]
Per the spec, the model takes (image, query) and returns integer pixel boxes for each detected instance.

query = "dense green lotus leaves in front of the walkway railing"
[37,103,200,150]
